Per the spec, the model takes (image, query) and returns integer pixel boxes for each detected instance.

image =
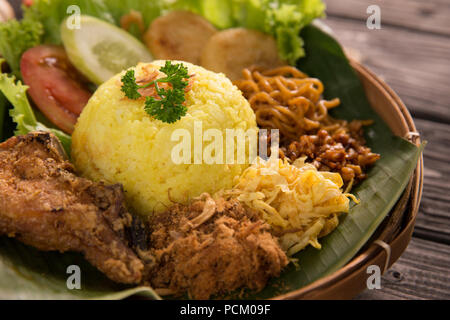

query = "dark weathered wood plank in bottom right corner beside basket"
[356,238,450,300]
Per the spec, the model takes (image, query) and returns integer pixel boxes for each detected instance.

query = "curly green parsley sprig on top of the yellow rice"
[121,61,189,123]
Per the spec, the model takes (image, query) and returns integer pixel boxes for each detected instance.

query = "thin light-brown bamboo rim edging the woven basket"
[272,58,423,300]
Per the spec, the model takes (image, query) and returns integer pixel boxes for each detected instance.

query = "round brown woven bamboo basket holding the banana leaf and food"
[274,61,423,300]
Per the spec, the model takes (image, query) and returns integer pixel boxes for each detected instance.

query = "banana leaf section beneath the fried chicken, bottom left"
[0,237,159,300]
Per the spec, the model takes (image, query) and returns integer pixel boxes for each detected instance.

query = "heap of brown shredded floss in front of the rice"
[148,195,288,299]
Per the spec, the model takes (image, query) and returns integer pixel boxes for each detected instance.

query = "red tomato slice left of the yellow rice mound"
[20,45,92,134]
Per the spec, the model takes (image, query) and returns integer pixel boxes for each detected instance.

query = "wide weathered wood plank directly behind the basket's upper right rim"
[325,17,450,123]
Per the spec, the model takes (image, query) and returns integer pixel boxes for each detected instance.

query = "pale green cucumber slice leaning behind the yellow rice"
[61,15,153,85]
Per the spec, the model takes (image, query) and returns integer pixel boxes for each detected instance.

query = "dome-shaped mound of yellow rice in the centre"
[72,61,257,215]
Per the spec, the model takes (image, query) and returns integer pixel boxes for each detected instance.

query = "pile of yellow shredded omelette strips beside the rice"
[223,158,357,256]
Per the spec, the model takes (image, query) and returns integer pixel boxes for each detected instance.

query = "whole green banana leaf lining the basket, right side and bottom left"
[0,26,422,299]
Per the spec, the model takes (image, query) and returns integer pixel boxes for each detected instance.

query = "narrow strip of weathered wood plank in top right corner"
[325,0,450,36]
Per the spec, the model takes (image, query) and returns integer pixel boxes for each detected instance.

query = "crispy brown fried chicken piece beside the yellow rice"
[0,132,144,284]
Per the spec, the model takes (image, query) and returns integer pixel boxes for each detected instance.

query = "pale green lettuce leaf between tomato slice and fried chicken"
[0,69,72,154]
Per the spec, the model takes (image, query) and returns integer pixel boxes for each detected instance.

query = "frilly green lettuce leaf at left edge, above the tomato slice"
[0,19,43,77]
